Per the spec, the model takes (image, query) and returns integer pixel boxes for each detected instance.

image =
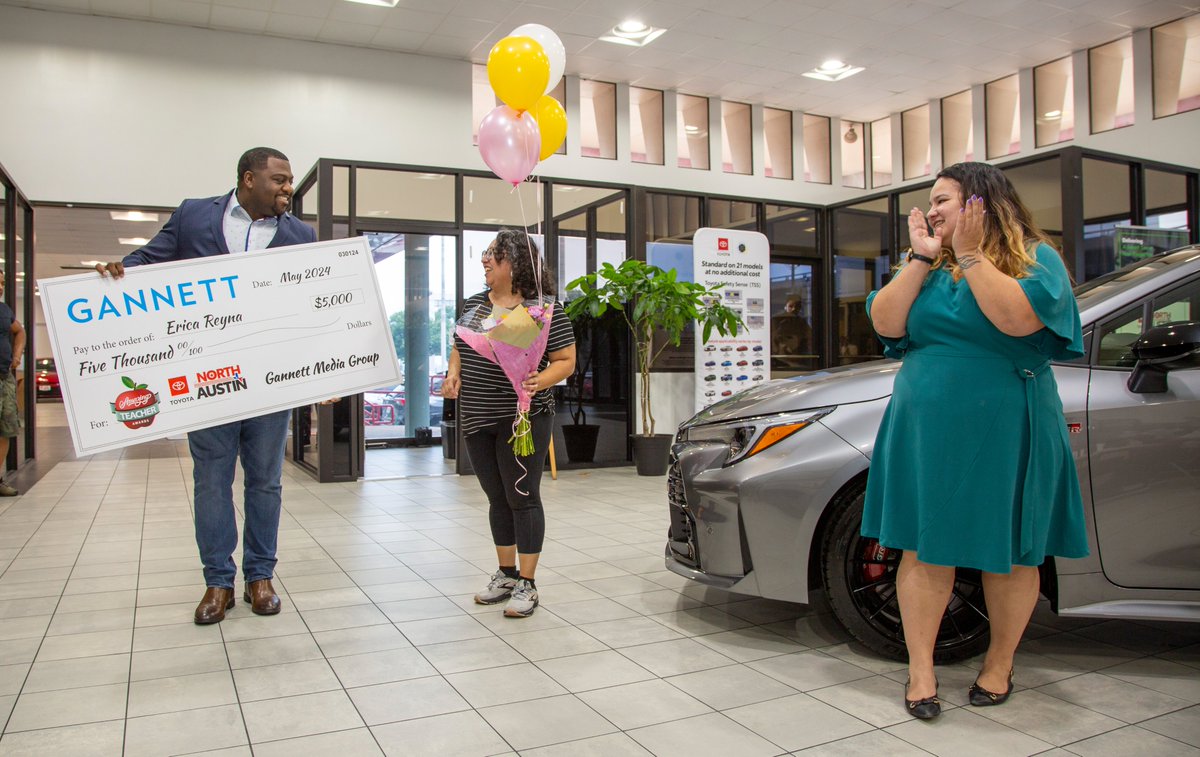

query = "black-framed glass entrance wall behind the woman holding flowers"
[292,160,629,481]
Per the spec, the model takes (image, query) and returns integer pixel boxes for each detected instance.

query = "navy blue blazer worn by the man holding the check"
[121,192,317,268]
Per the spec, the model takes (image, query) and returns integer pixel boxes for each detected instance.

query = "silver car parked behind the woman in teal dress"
[666,246,1200,661]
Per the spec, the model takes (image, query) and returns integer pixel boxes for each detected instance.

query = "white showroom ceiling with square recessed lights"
[0,0,1200,121]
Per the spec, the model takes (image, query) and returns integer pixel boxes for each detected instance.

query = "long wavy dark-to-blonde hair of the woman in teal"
[934,162,1054,281]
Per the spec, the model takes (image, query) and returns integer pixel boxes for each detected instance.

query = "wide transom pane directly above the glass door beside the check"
[354,168,455,223]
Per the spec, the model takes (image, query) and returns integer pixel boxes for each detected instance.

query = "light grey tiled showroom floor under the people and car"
[0,434,1200,757]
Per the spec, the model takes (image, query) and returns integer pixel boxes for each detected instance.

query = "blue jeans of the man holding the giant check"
[187,410,292,589]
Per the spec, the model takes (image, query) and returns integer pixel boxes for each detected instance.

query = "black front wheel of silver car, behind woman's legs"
[821,481,989,662]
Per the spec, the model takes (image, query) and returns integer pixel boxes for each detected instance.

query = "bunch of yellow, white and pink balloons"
[479,24,566,187]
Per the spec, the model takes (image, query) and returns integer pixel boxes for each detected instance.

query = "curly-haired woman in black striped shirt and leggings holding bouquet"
[442,229,575,618]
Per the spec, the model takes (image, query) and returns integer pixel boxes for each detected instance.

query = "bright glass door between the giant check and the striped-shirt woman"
[362,232,458,445]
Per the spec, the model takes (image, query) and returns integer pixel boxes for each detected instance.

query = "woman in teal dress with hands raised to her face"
[863,163,1087,719]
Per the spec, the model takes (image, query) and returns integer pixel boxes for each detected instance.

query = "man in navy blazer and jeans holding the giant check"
[96,148,317,625]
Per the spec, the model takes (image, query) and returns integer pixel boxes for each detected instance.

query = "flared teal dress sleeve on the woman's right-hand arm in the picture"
[1016,244,1084,360]
